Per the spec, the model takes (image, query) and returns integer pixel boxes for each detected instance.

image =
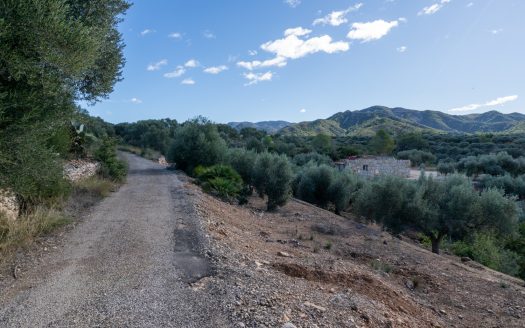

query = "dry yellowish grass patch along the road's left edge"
[0,207,71,258]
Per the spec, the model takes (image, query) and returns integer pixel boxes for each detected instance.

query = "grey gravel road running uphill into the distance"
[0,154,231,327]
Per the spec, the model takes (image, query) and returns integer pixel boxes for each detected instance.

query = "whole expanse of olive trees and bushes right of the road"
[116,117,525,278]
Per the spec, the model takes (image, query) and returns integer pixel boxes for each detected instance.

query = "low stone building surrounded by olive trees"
[335,156,410,178]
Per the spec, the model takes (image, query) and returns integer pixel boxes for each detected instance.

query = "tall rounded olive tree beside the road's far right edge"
[168,117,227,173]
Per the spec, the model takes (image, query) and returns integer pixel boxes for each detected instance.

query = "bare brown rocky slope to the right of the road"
[185,183,525,328]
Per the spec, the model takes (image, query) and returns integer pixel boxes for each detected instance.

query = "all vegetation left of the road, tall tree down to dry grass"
[0,0,129,259]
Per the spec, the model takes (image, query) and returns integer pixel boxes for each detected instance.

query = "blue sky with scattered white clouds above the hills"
[86,0,525,123]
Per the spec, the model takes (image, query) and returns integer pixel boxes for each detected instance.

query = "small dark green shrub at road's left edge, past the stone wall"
[95,138,127,182]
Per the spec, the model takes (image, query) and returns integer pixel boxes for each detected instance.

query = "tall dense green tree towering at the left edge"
[0,0,128,207]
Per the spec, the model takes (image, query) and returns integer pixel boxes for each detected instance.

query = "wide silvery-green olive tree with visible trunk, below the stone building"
[355,175,518,253]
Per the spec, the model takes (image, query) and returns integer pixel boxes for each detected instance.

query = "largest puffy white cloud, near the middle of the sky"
[261,28,350,59]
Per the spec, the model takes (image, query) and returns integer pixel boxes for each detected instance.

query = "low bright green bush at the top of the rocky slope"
[195,165,243,201]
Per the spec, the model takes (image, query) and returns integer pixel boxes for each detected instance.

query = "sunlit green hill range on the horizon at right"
[279,106,525,136]
